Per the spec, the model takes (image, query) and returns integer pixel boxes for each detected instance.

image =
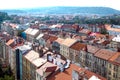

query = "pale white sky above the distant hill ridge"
[0,0,120,10]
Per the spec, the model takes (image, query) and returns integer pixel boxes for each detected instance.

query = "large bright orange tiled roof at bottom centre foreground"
[47,64,107,80]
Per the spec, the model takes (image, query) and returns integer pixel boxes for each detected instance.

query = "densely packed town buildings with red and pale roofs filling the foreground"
[0,22,120,80]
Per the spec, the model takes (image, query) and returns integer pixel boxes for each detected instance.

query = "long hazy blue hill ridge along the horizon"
[0,7,120,15]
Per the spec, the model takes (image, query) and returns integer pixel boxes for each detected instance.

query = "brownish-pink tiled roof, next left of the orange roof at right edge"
[95,49,115,60]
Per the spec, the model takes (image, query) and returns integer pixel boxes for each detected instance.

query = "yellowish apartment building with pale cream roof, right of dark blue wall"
[22,50,47,80]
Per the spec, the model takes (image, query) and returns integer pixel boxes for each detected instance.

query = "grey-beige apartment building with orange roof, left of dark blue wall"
[6,37,24,78]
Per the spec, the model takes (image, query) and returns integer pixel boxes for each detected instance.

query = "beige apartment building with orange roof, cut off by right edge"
[107,52,120,80]
